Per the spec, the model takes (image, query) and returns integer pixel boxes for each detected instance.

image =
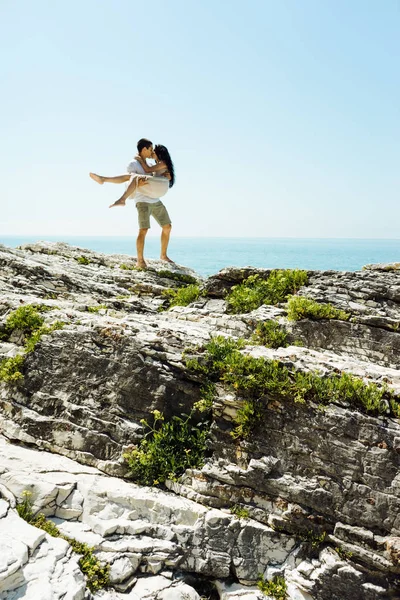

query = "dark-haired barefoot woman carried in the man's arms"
[89,144,175,208]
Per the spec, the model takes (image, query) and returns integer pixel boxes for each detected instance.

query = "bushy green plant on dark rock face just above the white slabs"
[123,410,210,485]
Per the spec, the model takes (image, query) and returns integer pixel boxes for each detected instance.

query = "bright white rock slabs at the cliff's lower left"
[0,437,295,600]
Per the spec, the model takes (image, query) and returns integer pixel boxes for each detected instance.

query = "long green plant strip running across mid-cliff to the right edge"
[186,336,400,438]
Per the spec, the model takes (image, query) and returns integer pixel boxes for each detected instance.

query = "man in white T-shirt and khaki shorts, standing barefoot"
[127,138,173,269]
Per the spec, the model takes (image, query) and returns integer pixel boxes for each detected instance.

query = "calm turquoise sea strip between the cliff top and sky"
[0,235,400,275]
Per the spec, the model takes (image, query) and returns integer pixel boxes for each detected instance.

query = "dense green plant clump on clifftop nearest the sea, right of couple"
[226,269,308,313]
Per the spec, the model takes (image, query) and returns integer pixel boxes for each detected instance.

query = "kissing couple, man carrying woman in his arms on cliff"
[90,138,175,269]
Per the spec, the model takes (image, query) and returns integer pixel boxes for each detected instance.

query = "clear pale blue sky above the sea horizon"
[0,0,400,239]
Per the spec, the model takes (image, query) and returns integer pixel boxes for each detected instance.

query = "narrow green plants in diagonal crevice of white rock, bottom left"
[17,491,110,593]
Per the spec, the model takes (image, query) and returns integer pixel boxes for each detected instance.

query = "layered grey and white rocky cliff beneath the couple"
[0,243,400,600]
